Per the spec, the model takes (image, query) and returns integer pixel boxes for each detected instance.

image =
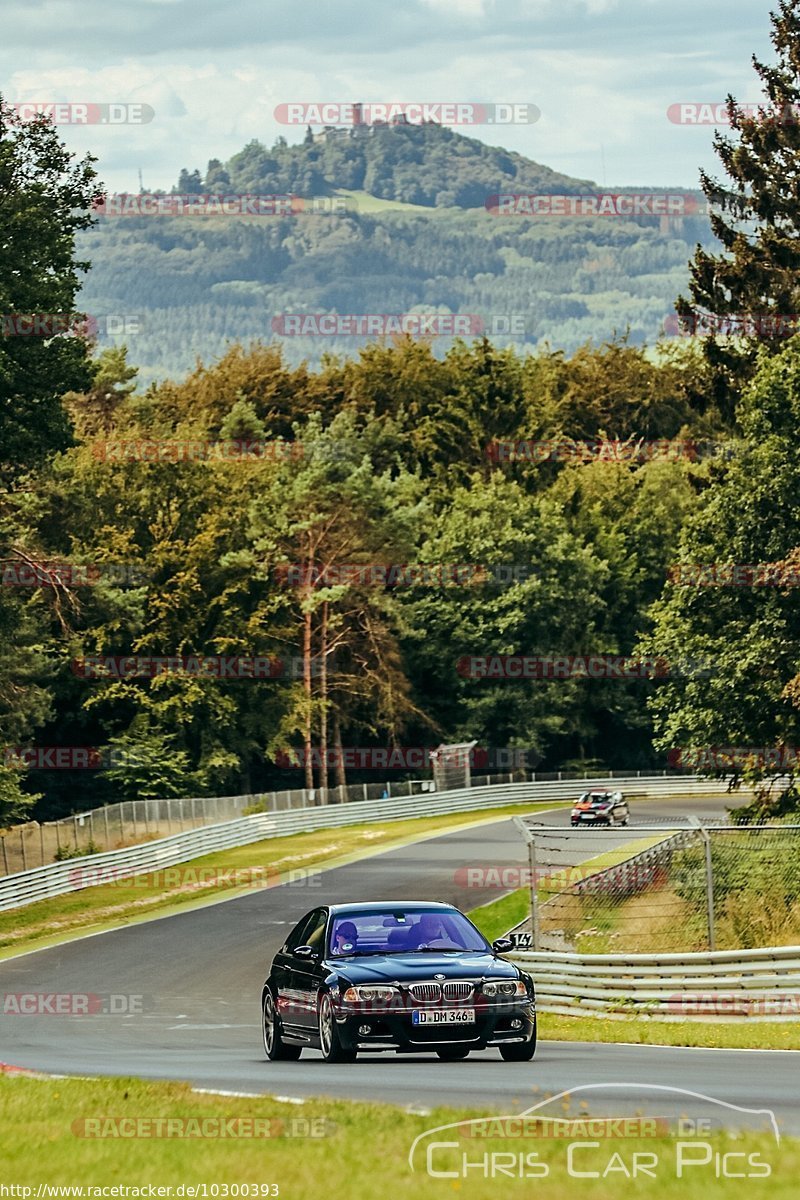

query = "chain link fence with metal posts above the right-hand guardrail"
[513,817,800,954]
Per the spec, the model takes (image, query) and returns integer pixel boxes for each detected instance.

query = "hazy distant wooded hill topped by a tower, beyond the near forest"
[78,125,711,385]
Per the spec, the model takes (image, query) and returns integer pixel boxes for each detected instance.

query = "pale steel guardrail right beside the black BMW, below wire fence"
[509,946,800,1022]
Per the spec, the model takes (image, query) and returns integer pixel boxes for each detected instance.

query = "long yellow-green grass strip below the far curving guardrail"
[0,802,569,959]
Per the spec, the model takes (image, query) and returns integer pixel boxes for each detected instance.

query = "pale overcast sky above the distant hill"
[0,0,774,191]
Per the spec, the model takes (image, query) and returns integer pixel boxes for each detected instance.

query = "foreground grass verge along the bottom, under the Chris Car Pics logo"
[0,1075,800,1200]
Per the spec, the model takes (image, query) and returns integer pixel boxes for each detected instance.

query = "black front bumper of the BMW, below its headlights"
[335,998,536,1051]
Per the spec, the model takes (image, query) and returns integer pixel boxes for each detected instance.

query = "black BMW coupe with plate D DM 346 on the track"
[261,900,536,1062]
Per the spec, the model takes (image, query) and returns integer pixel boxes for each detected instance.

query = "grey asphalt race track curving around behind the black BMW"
[0,799,800,1133]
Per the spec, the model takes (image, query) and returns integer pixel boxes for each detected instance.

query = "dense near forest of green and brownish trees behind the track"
[0,5,800,822]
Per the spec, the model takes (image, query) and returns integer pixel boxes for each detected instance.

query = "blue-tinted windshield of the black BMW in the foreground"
[329,908,489,956]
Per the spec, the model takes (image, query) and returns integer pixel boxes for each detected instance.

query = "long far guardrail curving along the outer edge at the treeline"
[0,776,723,911]
